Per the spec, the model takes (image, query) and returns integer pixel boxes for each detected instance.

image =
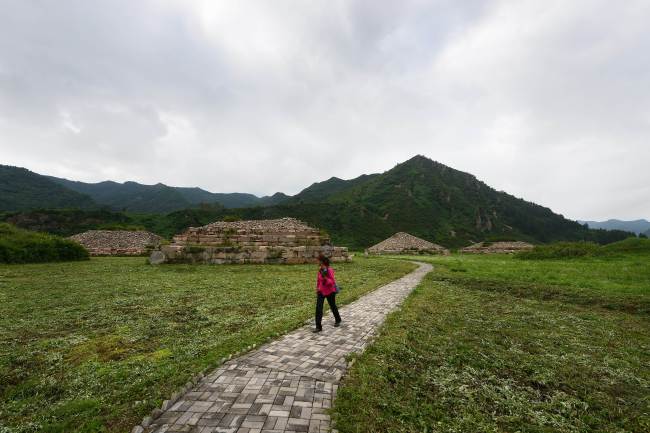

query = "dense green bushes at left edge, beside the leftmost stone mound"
[0,223,88,263]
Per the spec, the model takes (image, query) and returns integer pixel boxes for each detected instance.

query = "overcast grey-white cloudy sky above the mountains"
[0,0,650,219]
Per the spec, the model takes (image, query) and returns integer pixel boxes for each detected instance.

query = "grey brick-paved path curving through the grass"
[144,263,431,433]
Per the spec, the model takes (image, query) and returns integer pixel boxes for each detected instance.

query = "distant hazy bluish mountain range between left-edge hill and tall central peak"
[49,177,286,213]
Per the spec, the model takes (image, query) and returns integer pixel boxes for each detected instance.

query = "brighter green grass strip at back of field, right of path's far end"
[419,254,650,313]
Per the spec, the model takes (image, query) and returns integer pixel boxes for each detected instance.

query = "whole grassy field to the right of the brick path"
[333,254,650,433]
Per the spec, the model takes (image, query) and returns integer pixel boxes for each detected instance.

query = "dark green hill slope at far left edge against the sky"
[0,165,96,211]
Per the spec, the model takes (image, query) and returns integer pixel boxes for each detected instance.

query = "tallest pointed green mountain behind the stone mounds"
[241,156,630,247]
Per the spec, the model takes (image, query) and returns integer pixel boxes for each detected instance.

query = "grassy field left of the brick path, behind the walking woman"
[0,258,414,433]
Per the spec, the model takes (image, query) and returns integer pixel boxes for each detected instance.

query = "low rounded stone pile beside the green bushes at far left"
[70,230,162,256]
